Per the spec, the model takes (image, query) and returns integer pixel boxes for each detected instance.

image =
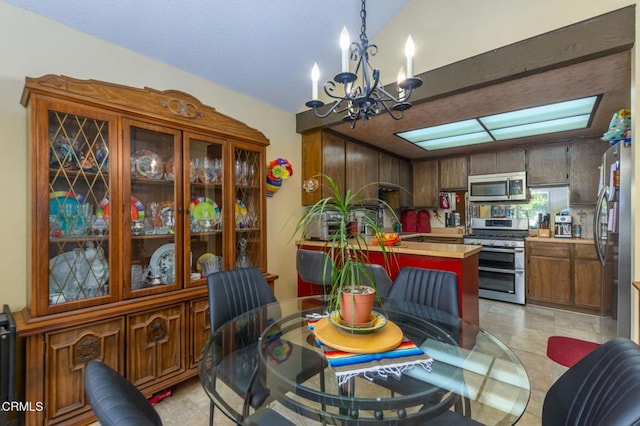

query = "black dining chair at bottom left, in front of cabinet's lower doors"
[84,360,162,426]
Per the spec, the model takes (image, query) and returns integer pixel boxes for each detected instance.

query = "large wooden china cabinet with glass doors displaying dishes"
[17,75,275,425]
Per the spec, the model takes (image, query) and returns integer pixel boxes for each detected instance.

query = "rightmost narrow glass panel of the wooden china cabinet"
[232,147,265,269]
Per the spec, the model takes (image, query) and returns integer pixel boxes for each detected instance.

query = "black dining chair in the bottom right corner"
[542,337,640,426]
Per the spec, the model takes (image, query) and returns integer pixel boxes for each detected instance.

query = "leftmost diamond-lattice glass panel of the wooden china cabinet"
[48,110,109,304]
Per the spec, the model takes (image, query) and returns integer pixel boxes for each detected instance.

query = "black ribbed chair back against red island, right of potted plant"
[388,266,460,317]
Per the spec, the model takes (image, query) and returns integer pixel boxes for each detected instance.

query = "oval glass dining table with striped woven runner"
[199,296,530,425]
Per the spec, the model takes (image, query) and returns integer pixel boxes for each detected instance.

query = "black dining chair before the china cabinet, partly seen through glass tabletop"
[207,268,323,425]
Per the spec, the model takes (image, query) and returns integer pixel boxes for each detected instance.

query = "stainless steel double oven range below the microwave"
[464,218,529,305]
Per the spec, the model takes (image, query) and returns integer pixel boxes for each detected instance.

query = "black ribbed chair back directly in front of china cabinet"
[207,268,276,332]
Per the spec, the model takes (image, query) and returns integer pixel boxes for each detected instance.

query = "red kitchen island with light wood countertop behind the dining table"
[297,240,482,327]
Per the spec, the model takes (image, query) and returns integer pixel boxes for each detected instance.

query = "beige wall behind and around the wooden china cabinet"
[0,1,301,311]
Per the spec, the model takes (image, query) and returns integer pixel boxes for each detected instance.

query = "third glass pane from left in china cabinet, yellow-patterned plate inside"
[184,133,226,286]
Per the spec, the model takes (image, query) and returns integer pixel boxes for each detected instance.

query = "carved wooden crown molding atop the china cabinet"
[20,74,269,146]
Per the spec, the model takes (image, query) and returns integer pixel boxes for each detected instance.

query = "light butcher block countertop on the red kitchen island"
[297,238,482,259]
